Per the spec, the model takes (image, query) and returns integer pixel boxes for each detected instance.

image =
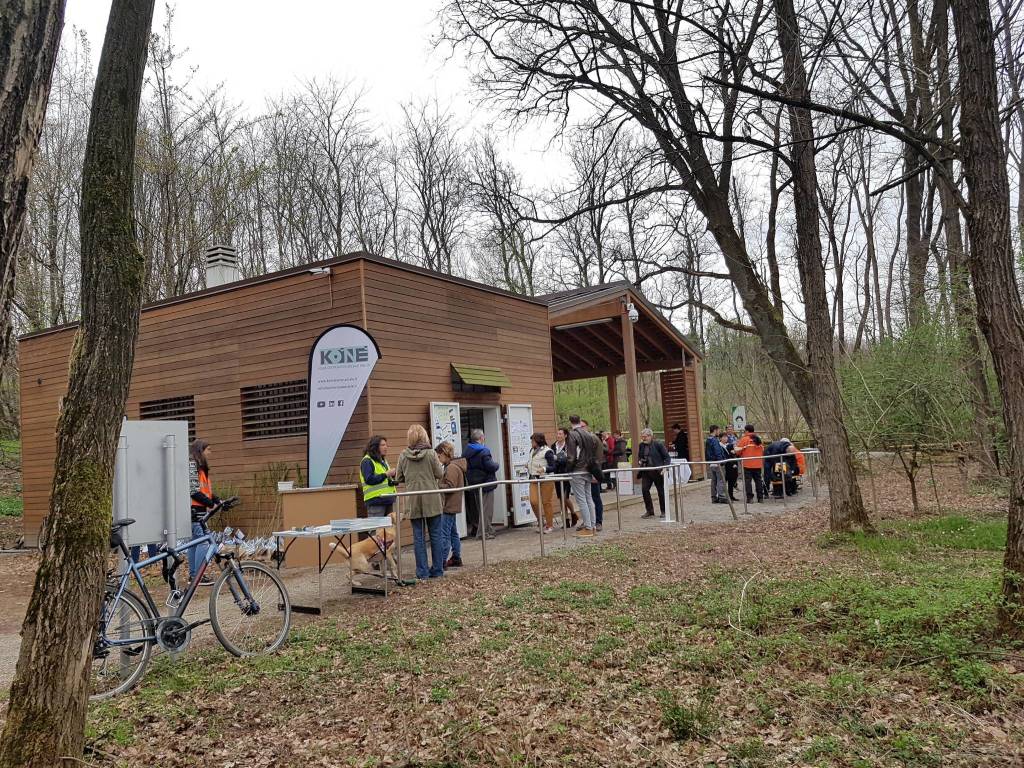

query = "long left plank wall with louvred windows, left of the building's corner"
[20,262,368,542]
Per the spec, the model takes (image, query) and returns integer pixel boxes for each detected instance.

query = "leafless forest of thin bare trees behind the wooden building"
[3,0,1024,444]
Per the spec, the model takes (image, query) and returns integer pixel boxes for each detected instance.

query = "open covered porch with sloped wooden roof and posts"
[542,281,703,474]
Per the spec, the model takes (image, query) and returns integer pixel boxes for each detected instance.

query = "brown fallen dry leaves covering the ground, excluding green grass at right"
[6,469,1024,768]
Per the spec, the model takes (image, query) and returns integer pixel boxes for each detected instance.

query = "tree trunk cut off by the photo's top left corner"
[0,0,65,368]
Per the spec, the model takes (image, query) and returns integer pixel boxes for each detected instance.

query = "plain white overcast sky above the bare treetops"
[65,0,573,183]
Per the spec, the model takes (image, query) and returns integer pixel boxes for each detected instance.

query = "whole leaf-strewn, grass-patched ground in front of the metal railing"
[0,468,1024,768]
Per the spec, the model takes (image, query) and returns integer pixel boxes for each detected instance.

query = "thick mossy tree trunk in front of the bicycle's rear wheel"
[0,0,154,768]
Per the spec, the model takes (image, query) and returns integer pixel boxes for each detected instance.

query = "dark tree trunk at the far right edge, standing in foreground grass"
[950,0,1024,636]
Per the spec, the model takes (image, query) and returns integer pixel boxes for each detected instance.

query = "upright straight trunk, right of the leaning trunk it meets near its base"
[775,0,871,530]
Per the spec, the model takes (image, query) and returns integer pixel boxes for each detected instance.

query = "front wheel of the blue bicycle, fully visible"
[210,562,292,656]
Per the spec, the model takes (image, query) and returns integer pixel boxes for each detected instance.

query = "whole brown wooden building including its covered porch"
[19,253,700,544]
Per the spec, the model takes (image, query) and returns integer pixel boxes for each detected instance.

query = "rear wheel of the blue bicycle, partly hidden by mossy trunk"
[89,590,153,701]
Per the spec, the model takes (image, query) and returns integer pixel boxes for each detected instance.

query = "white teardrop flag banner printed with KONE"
[306,325,381,488]
